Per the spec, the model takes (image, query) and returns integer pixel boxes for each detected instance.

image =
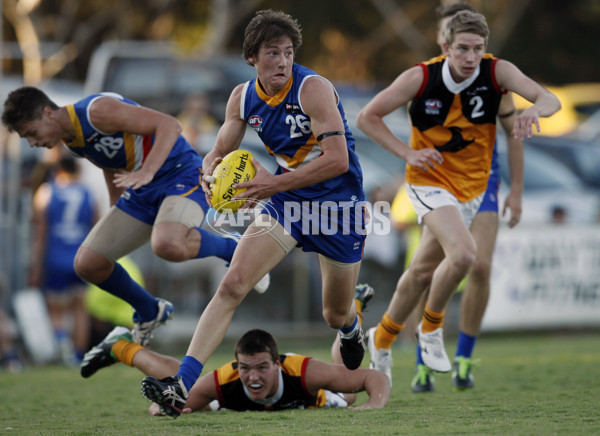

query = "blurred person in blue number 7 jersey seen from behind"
[29,155,98,365]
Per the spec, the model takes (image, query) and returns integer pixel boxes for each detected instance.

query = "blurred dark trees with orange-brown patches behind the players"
[2,0,600,84]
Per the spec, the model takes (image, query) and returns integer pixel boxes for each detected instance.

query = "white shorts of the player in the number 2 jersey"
[406,184,485,228]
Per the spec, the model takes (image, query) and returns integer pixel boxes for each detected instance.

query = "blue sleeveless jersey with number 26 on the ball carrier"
[240,64,365,201]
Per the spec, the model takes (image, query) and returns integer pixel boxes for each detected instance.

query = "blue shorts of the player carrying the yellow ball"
[262,195,368,263]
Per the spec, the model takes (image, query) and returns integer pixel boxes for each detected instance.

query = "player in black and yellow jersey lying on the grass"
[81,285,390,415]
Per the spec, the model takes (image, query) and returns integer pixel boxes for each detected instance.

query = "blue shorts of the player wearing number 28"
[115,153,210,225]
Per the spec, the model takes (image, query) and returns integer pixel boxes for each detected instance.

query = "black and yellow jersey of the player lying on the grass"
[213,354,326,411]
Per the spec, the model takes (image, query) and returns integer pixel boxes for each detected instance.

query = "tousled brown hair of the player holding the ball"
[243,9,302,65]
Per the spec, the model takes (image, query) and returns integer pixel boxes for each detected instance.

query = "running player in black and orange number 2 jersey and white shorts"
[357,11,560,392]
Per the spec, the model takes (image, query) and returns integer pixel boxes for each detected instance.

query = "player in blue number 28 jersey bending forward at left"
[2,86,268,346]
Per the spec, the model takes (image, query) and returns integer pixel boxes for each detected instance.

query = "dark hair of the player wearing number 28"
[2,86,58,132]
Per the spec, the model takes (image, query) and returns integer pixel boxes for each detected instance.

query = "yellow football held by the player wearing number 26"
[210,150,256,213]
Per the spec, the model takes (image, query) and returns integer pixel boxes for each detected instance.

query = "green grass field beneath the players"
[0,331,600,436]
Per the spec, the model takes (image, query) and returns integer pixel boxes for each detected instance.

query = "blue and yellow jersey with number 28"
[65,93,196,178]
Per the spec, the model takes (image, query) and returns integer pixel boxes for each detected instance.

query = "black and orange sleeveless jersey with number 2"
[406,54,503,202]
